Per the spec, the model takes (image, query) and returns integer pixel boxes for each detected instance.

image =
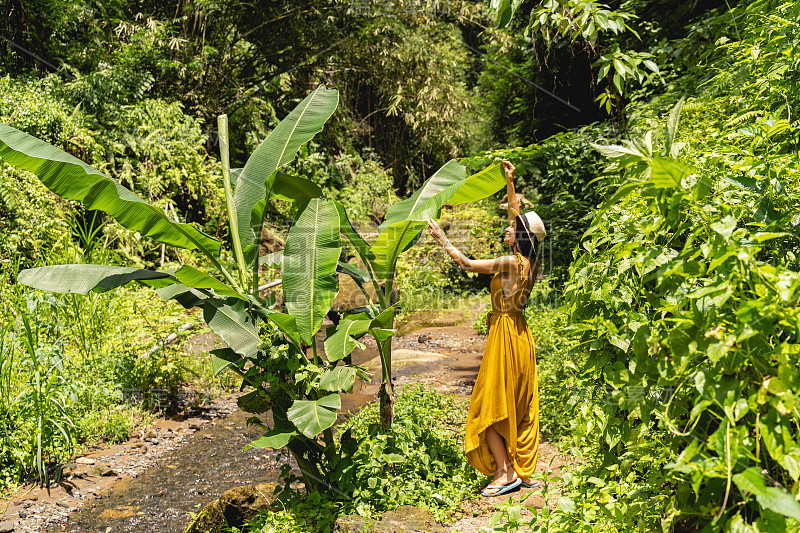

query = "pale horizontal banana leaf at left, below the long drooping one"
[17,265,172,294]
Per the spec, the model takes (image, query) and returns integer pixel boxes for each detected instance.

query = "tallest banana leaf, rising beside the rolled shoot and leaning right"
[233,86,339,250]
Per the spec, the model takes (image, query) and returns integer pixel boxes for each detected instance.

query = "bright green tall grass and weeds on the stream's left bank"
[0,258,211,491]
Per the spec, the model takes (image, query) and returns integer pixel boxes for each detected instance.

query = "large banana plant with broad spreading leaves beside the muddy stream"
[0,87,505,490]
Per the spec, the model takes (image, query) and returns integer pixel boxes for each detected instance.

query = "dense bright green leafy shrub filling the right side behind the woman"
[562,106,800,531]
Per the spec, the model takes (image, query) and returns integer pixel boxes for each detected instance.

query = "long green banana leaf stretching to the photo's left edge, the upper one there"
[0,124,222,257]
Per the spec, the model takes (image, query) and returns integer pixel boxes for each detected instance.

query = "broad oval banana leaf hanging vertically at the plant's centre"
[281,198,341,345]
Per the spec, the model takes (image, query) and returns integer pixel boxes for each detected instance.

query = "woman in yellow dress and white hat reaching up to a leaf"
[428,161,546,496]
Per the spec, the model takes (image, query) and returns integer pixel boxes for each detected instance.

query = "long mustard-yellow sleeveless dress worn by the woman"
[464,254,539,477]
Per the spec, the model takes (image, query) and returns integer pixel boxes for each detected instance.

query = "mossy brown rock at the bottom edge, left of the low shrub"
[184,483,277,533]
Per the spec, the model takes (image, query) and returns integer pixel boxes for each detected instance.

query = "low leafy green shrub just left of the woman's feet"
[336,386,483,519]
